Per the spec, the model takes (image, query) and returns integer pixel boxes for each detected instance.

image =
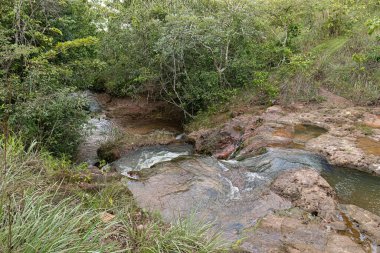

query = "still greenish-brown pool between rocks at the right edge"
[322,167,380,215]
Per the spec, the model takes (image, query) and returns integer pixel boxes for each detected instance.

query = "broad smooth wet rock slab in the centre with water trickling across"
[127,149,332,241]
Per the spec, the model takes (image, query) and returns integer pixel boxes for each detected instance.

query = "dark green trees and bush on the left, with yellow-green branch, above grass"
[0,0,102,155]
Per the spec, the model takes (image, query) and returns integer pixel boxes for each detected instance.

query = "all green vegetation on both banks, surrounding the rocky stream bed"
[0,0,380,252]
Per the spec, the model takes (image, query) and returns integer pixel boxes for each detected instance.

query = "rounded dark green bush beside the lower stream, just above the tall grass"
[10,90,87,155]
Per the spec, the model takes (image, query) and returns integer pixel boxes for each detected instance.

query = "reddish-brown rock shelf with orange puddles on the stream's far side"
[190,106,380,175]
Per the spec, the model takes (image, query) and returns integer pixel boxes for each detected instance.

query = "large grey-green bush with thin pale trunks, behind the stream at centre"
[96,1,277,116]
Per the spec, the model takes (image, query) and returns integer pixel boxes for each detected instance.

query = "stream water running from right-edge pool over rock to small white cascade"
[121,145,380,218]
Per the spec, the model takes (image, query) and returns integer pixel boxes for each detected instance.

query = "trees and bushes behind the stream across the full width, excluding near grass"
[0,0,380,155]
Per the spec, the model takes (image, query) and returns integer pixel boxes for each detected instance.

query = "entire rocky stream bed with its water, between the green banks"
[78,94,380,253]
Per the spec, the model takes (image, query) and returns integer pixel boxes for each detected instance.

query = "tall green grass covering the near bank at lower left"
[0,137,226,253]
